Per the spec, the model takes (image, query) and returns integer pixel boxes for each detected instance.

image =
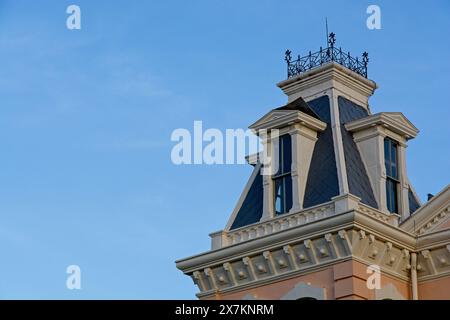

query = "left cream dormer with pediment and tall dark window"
[250,97,327,221]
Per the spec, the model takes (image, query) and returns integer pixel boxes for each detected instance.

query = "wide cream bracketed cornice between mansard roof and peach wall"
[176,207,450,298]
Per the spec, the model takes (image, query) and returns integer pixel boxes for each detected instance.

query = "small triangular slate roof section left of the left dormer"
[230,166,263,230]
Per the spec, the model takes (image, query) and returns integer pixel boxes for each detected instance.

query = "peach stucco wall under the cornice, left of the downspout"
[206,260,414,300]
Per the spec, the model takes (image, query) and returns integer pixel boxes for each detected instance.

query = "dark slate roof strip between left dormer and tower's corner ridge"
[303,96,339,208]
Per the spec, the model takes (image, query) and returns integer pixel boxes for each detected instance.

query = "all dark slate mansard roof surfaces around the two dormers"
[228,95,400,229]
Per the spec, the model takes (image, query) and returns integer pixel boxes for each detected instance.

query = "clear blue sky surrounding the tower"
[0,0,450,299]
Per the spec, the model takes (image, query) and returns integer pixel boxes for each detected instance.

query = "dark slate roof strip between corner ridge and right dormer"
[338,96,378,208]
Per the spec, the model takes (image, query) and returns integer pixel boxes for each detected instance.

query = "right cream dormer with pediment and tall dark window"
[345,112,419,220]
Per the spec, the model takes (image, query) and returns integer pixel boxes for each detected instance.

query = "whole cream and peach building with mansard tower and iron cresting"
[176,34,450,300]
